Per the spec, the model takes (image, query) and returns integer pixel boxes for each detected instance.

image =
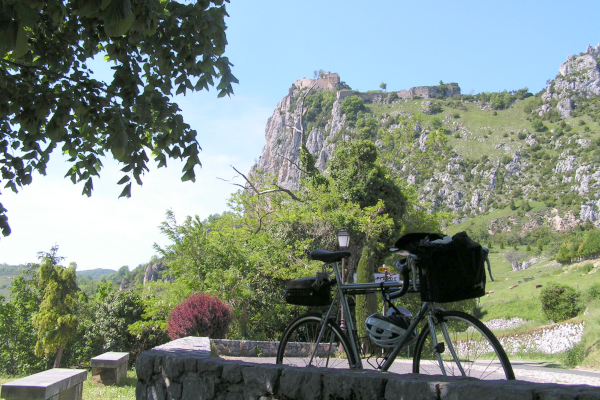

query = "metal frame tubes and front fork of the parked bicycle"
[309,261,465,375]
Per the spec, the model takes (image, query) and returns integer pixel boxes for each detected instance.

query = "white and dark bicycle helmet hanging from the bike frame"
[365,313,417,347]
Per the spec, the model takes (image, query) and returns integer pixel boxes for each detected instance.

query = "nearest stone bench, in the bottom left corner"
[0,368,88,400]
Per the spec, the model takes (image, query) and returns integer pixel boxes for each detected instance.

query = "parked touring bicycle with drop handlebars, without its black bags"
[276,242,515,380]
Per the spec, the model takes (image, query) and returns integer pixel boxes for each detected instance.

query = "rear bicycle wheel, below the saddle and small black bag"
[276,314,354,368]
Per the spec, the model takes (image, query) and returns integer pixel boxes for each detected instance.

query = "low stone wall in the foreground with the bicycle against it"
[136,338,600,400]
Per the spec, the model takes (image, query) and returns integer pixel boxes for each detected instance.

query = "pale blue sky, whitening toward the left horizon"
[0,0,600,270]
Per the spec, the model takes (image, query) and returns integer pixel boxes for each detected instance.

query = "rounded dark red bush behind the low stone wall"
[167,293,232,339]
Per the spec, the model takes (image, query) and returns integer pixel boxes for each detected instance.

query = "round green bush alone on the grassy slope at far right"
[540,283,582,322]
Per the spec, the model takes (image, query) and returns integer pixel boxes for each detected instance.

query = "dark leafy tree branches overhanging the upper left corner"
[0,0,237,236]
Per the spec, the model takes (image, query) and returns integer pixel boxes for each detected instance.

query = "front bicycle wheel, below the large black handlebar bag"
[413,311,515,380]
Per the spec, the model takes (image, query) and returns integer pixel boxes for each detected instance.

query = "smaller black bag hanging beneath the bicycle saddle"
[285,276,331,307]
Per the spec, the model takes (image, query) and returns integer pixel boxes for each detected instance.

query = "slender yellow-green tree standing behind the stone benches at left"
[33,246,79,368]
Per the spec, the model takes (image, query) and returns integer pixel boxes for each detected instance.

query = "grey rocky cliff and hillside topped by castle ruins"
[251,45,600,232]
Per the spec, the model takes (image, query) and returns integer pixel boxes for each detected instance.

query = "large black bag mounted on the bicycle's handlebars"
[396,232,485,303]
